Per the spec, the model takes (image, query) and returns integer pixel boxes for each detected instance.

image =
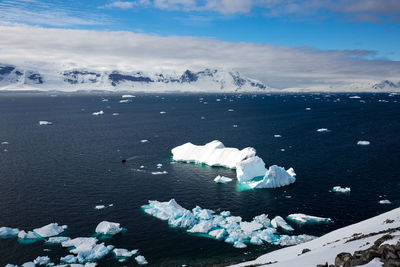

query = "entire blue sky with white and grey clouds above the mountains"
[0,0,400,88]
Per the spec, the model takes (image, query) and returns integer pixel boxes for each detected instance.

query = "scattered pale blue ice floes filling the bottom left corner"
[0,221,147,267]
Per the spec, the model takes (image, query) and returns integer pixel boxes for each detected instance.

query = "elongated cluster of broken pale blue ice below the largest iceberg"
[142,199,314,248]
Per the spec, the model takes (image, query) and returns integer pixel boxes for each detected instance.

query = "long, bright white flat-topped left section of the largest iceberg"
[171,140,256,169]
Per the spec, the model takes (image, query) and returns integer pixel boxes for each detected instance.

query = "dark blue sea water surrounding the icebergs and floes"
[0,94,400,266]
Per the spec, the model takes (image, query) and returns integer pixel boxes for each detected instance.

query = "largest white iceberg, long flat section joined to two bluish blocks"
[171,140,296,188]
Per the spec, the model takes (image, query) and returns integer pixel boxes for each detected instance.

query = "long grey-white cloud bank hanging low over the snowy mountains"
[0,26,400,88]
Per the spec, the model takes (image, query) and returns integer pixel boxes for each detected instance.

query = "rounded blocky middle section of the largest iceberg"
[236,156,267,182]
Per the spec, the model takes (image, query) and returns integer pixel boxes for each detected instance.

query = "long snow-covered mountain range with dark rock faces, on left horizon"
[0,64,269,92]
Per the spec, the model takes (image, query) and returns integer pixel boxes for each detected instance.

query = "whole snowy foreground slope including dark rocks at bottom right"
[233,208,400,267]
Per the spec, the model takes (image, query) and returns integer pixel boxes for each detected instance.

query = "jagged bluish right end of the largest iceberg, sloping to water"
[249,165,296,188]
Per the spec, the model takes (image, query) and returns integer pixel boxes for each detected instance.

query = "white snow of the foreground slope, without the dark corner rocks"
[232,208,400,267]
